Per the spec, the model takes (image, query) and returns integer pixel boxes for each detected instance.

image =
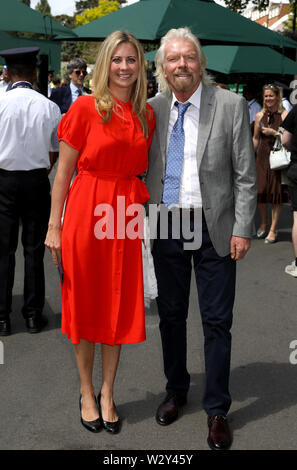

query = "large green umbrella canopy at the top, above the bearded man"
[60,0,297,47]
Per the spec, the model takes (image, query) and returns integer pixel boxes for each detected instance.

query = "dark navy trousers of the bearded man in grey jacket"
[153,212,236,416]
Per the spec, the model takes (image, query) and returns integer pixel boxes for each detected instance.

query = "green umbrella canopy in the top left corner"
[0,0,76,37]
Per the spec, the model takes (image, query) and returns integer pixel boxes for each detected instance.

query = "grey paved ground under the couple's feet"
[0,189,297,451]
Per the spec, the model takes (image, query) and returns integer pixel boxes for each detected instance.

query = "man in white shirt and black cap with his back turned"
[0,47,61,336]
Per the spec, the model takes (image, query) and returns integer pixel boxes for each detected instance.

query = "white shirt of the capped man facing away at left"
[0,88,61,171]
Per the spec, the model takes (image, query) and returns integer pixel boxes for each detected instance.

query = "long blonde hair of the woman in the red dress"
[93,31,148,137]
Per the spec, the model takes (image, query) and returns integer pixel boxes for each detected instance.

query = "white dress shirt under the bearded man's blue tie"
[167,83,202,207]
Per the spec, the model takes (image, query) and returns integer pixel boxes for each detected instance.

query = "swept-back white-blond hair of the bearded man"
[155,27,213,92]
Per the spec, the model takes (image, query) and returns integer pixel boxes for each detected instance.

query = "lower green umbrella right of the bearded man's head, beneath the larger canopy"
[145,46,297,75]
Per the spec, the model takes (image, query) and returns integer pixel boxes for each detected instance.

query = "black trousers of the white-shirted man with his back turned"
[0,169,50,320]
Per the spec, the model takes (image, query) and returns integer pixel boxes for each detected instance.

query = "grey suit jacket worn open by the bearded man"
[146,85,257,256]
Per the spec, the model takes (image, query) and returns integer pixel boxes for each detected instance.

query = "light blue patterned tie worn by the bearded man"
[163,101,191,207]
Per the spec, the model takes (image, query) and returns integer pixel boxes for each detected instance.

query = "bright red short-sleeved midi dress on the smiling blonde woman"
[58,96,155,345]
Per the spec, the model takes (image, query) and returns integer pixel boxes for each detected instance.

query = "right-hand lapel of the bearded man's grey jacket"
[197,85,216,168]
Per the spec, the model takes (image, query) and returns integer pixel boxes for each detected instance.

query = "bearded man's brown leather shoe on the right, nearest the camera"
[207,415,232,450]
